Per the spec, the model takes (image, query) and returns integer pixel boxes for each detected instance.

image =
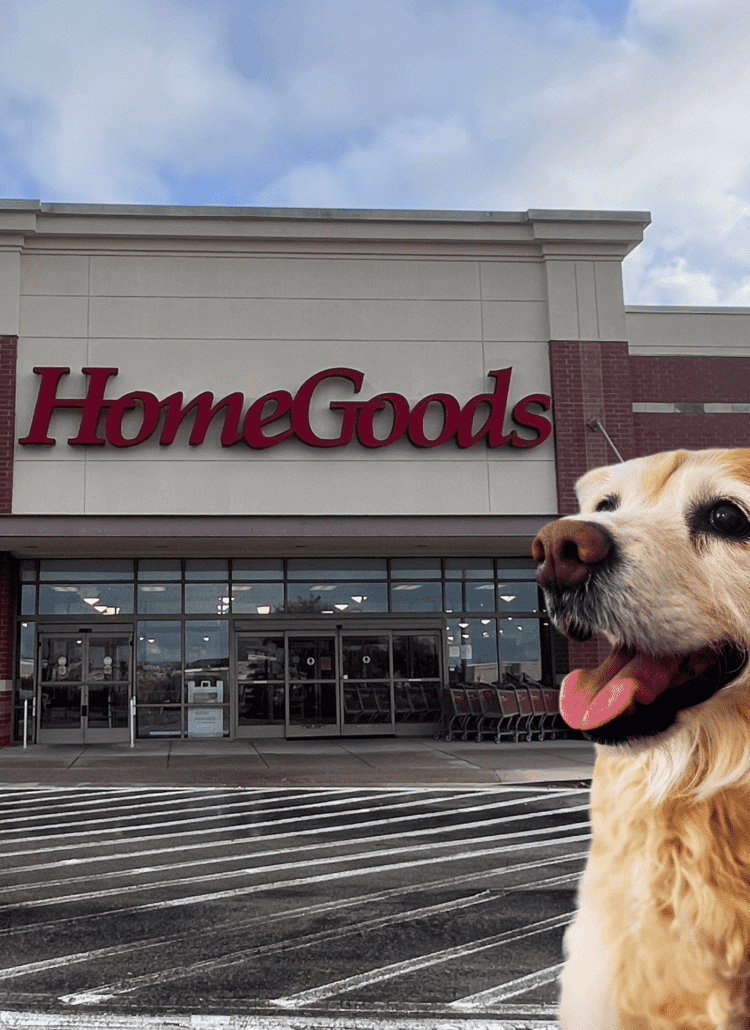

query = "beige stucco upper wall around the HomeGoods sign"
[0,206,643,515]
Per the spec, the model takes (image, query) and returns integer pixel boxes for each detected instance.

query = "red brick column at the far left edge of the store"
[0,336,18,747]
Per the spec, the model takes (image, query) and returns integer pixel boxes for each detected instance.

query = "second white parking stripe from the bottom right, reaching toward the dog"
[269,912,575,1008]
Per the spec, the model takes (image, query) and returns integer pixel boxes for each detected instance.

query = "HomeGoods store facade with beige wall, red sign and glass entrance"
[0,201,750,743]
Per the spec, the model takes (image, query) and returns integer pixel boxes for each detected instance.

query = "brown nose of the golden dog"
[532,518,613,590]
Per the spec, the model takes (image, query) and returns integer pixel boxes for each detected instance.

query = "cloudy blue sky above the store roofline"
[0,0,750,306]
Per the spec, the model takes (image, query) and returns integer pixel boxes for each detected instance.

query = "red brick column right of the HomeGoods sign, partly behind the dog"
[549,340,636,668]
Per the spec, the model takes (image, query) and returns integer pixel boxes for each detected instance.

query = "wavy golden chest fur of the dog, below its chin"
[560,749,750,1030]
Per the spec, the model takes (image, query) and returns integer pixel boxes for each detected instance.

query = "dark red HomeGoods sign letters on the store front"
[19,367,552,450]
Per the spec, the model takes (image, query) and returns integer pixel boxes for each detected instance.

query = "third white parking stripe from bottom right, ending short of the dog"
[60,891,500,1005]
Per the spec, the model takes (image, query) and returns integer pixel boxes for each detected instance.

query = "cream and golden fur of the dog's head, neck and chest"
[560,450,750,1030]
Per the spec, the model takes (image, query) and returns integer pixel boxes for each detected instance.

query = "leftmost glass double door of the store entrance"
[37,631,133,744]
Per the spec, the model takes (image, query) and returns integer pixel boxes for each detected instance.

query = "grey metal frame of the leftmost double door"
[35,623,135,745]
